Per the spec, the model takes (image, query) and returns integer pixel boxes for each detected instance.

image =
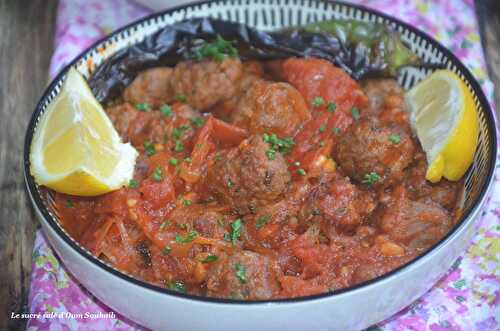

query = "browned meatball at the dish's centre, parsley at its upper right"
[208,135,290,214]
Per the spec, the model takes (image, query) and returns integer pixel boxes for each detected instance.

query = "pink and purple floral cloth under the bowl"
[27,0,500,331]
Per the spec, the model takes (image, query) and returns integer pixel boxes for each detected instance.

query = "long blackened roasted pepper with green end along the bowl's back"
[89,18,432,102]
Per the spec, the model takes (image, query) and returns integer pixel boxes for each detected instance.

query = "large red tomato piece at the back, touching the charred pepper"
[282,58,368,112]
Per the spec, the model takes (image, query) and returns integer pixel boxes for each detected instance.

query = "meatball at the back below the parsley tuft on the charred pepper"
[172,58,242,111]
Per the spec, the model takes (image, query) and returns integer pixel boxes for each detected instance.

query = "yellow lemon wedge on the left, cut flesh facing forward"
[30,68,138,196]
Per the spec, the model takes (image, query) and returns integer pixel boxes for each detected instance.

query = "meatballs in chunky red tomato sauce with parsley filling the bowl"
[56,59,462,299]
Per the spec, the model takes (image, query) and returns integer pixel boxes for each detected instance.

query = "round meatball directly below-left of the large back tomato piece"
[230,80,311,137]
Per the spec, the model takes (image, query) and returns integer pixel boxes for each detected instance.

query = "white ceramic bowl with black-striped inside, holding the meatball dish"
[24,0,496,331]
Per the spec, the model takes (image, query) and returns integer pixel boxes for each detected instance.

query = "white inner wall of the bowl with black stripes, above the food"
[24,0,496,304]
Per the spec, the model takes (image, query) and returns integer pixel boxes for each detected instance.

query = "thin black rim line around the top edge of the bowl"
[24,0,497,305]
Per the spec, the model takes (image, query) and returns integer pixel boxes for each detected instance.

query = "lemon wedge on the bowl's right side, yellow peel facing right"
[405,70,479,183]
